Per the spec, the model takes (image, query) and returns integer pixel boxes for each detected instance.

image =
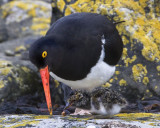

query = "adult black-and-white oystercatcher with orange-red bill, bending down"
[29,13,123,114]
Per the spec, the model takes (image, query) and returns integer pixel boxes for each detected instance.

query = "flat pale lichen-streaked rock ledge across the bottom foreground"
[0,113,160,128]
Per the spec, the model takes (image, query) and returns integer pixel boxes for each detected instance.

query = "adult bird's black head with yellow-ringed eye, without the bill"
[29,36,62,70]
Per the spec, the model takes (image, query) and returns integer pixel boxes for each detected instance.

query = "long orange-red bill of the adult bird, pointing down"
[40,66,52,115]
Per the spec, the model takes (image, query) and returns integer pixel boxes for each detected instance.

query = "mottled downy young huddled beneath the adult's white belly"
[66,87,127,116]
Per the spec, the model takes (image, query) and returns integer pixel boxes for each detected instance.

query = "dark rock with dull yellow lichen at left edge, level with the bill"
[0,60,39,102]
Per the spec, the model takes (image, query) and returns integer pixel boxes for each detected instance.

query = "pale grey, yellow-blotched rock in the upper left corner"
[1,0,51,38]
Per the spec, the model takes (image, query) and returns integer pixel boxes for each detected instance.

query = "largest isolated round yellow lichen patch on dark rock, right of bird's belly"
[132,64,149,82]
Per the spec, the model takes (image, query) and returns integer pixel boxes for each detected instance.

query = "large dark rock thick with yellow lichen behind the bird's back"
[52,0,160,101]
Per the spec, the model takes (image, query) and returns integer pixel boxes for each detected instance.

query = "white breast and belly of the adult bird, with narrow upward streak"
[50,36,115,91]
